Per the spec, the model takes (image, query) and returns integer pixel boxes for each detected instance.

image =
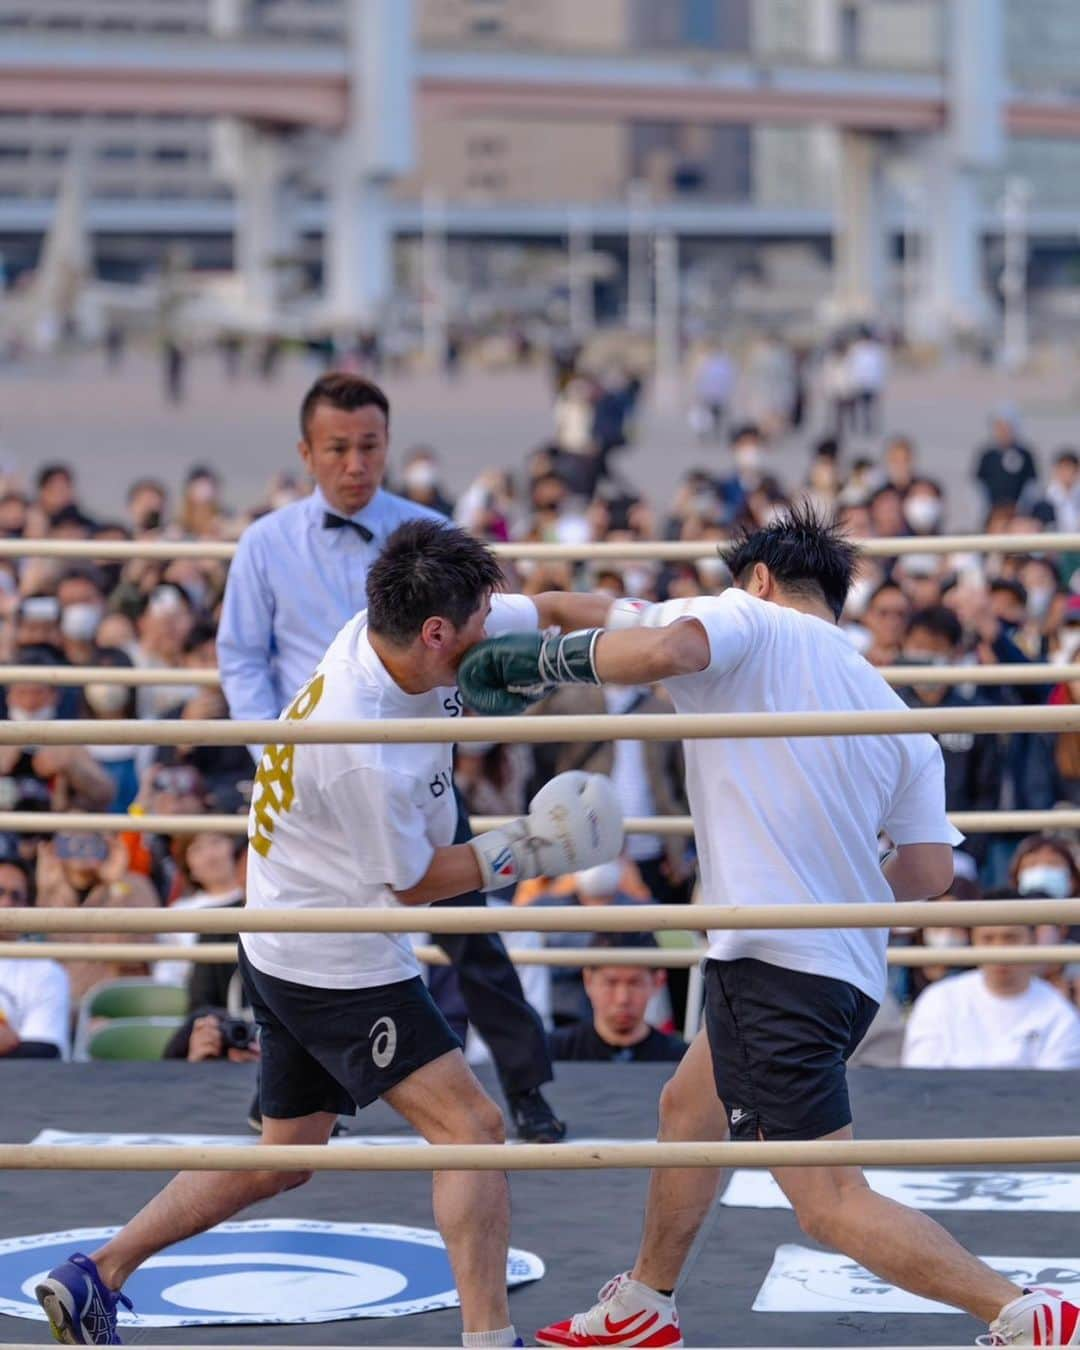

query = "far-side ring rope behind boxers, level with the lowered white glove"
[0,807,1080,837]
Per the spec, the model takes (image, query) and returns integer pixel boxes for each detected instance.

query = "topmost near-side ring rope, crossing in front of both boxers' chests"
[0,705,1080,748]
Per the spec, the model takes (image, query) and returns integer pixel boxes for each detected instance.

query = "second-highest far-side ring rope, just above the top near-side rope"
[8,662,1080,689]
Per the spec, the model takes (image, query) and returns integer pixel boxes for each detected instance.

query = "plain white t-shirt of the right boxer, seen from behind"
[643,587,963,1003]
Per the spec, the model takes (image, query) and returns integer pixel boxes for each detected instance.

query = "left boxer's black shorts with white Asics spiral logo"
[239,944,462,1121]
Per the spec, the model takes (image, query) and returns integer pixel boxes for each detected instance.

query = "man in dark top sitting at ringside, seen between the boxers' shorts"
[548,933,686,1064]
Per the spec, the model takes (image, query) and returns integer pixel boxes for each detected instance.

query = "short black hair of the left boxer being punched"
[367,518,502,647]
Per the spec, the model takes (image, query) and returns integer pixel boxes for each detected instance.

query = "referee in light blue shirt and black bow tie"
[217,373,566,1143]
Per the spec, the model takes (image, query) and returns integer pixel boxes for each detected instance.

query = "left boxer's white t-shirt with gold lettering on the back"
[243,595,539,990]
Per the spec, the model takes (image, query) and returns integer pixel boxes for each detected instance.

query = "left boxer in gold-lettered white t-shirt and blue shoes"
[35,520,622,1346]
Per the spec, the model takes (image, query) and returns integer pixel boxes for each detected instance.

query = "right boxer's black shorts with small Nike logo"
[705,957,878,1139]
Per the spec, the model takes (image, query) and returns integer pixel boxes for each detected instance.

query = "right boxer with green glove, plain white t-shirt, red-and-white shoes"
[459,510,1080,1347]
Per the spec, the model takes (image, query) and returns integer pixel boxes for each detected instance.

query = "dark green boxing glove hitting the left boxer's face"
[458,628,603,717]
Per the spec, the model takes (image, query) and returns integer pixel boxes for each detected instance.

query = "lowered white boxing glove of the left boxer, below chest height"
[468,770,622,891]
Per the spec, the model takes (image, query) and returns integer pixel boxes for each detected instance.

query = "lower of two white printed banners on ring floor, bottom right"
[753,1242,1080,1314]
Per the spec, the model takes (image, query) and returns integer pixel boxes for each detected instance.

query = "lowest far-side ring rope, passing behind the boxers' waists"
[0,945,1080,971]
